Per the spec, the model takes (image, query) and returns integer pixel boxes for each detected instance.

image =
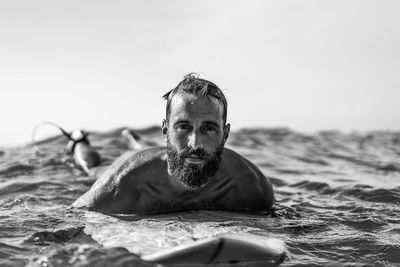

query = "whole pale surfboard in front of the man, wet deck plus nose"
[83,211,288,267]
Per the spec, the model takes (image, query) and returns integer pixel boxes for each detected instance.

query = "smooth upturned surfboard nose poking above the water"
[141,234,287,267]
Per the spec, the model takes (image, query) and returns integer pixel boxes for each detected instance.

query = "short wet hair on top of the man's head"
[163,72,228,124]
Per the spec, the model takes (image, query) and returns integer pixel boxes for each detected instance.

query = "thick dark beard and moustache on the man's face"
[167,140,224,190]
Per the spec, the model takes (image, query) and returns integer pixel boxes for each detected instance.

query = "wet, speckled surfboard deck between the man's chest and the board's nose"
[85,211,260,255]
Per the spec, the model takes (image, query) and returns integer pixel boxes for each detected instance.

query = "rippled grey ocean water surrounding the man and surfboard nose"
[0,127,400,266]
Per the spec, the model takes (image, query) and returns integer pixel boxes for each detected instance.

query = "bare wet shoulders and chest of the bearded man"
[73,147,274,214]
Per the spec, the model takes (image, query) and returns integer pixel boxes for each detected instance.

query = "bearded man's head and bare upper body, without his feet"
[73,74,274,214]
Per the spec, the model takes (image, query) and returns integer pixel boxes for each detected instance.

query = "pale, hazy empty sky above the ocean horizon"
[0,0,400,146]
